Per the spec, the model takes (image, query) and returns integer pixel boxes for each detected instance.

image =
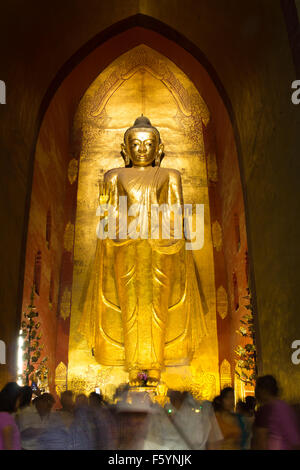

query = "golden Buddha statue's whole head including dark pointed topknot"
[121,115,164,167]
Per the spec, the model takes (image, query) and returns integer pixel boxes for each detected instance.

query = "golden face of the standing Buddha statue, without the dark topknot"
[121,129,163,167]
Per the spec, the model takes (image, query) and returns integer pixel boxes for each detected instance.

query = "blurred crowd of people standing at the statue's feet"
[0,375,300,450]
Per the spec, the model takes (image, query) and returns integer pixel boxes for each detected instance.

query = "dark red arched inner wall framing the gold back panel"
[23,24,251,391]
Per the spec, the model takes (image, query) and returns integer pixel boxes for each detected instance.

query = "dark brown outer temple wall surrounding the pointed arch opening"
[0,0,300,399]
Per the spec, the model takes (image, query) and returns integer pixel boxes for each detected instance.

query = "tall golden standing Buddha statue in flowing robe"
[80,115,206,386]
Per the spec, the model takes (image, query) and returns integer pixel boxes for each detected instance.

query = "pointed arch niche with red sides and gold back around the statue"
[24,27,247,398]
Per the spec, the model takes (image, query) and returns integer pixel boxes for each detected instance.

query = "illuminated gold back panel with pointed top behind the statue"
[68,46,219,395]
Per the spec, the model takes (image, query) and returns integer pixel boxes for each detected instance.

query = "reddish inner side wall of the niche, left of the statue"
[22,94,69,392]
